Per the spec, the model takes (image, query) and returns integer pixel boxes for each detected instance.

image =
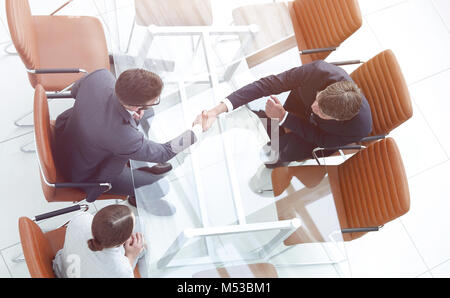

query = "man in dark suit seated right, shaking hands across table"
[203,60,372,167]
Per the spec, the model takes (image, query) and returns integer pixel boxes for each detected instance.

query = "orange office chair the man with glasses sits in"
[34,85,127,202]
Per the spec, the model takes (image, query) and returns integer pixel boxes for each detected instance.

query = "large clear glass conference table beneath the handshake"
[94,0,348,277]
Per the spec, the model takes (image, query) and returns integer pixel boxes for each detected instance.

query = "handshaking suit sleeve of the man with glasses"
[114,130,197,163]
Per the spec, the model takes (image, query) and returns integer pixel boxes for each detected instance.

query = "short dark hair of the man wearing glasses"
[115,69,164,105]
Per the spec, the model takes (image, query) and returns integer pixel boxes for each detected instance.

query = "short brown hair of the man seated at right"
[317,81,363,120]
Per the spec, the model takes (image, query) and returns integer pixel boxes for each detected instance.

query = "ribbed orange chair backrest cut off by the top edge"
[289,0,362,64]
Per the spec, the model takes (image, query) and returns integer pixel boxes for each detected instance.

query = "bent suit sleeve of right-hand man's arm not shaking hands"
[283,114,361,148]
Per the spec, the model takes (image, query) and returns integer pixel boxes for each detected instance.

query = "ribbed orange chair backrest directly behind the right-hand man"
[350,50,413,135]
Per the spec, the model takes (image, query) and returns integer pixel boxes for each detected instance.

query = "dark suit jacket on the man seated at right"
[228,60,372,147]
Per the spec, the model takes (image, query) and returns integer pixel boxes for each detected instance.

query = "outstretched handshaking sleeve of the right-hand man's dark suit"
[227,62,317,109]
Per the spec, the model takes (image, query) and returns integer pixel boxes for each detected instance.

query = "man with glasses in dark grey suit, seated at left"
[55,69,201,216]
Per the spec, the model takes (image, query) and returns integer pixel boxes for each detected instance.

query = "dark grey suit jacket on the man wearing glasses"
[55,69,196,182]
